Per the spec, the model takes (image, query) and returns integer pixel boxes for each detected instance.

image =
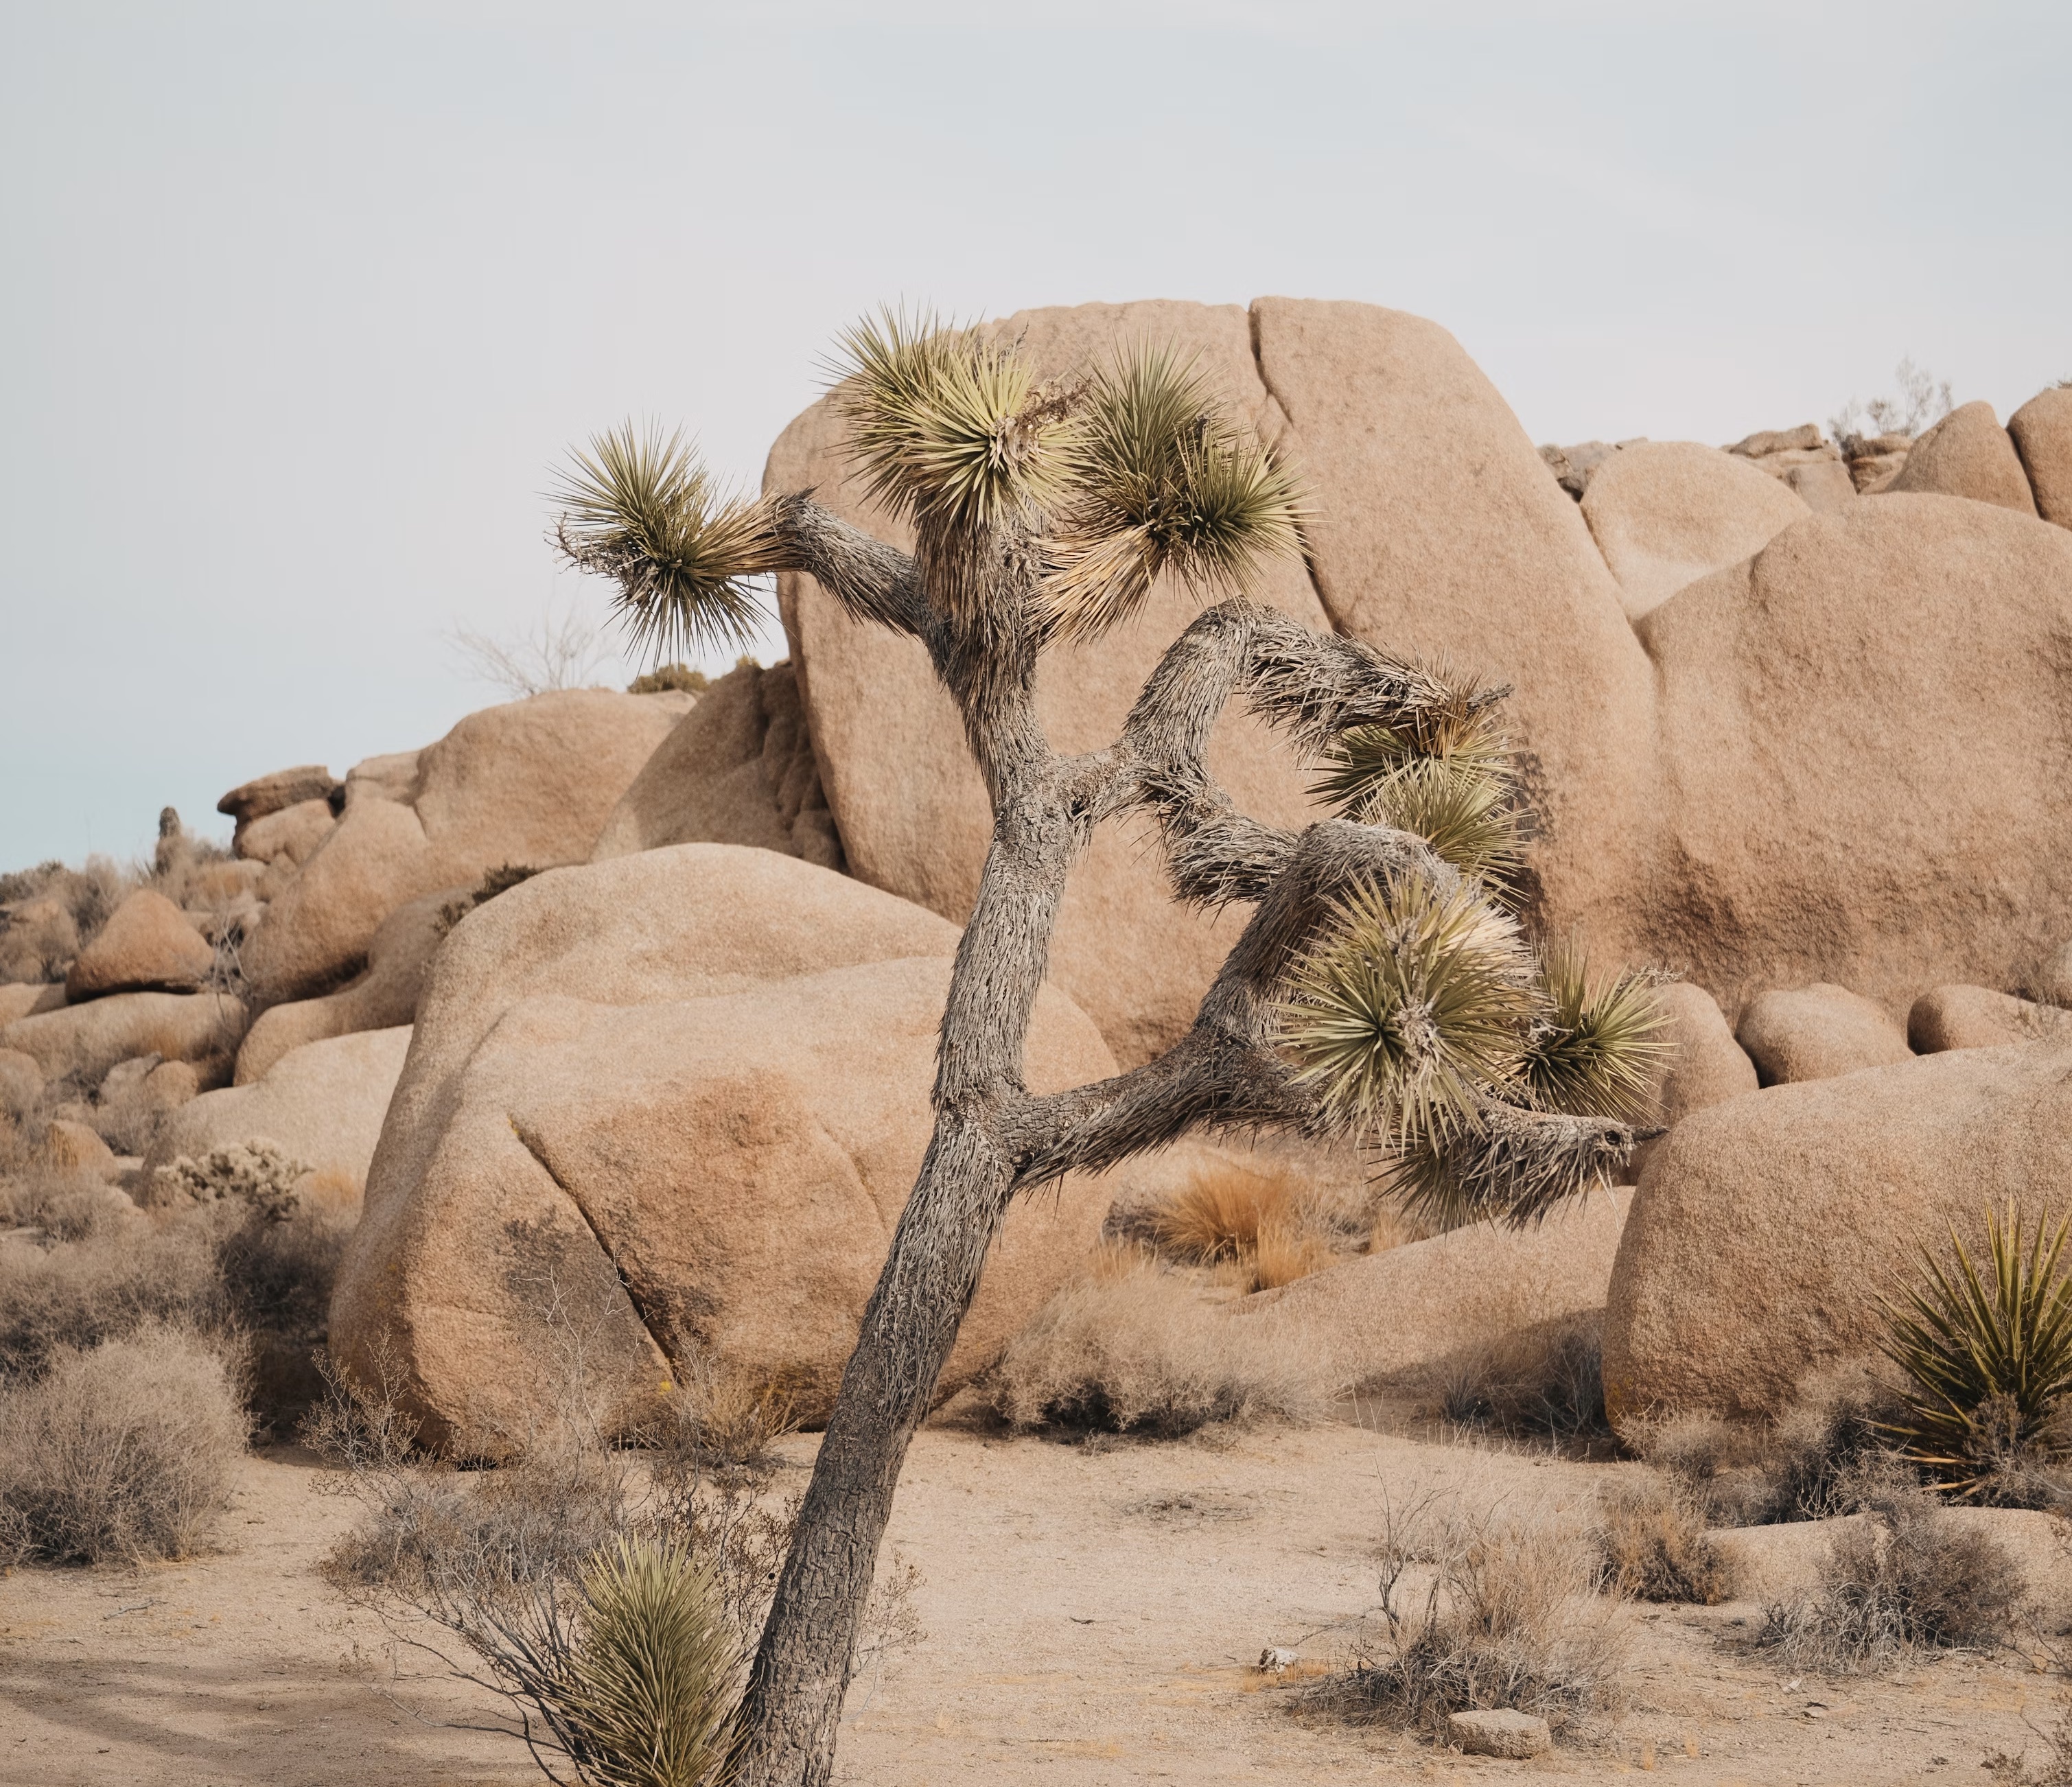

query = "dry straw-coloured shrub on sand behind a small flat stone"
[1314,1493,1625,1740]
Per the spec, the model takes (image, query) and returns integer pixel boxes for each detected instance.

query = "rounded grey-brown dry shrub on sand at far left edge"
[0,1327,246,1563]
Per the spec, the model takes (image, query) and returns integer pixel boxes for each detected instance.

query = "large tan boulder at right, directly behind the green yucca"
[1604,1044,2072,1425]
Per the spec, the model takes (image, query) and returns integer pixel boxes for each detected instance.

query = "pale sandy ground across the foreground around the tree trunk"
[0,1425,2056,1787]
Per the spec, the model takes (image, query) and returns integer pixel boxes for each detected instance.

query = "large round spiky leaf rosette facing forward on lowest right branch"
[1281,876,1533,1147]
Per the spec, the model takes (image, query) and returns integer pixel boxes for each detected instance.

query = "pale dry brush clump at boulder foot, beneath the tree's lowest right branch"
[986,1246,1332,1439]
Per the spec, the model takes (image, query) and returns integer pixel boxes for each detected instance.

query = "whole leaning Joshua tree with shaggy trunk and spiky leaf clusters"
[557,315,1655,1787]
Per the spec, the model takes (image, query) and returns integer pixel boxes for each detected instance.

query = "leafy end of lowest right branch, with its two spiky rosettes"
[1281,878,1664,1228]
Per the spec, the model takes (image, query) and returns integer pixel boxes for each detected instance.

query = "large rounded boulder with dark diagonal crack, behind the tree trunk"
[331,845,1185,1453]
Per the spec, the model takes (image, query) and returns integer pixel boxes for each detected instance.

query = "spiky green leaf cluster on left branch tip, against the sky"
[555,423,779,663]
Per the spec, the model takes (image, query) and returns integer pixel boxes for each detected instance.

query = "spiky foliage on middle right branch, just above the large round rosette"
[1309,688,1525,895]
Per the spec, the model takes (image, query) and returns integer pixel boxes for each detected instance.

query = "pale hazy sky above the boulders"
[0,0,2072,867]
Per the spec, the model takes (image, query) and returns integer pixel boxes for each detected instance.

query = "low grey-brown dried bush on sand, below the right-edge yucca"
[1757,1484,2025,1675]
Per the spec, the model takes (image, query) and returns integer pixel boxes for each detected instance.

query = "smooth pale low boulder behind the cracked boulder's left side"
[143,1025,410,1187]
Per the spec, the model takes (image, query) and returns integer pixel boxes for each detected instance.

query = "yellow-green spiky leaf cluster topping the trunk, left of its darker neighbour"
[835,311,1075,528]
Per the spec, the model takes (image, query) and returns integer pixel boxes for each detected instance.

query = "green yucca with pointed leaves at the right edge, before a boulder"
[1879,1203,2072,1499]
